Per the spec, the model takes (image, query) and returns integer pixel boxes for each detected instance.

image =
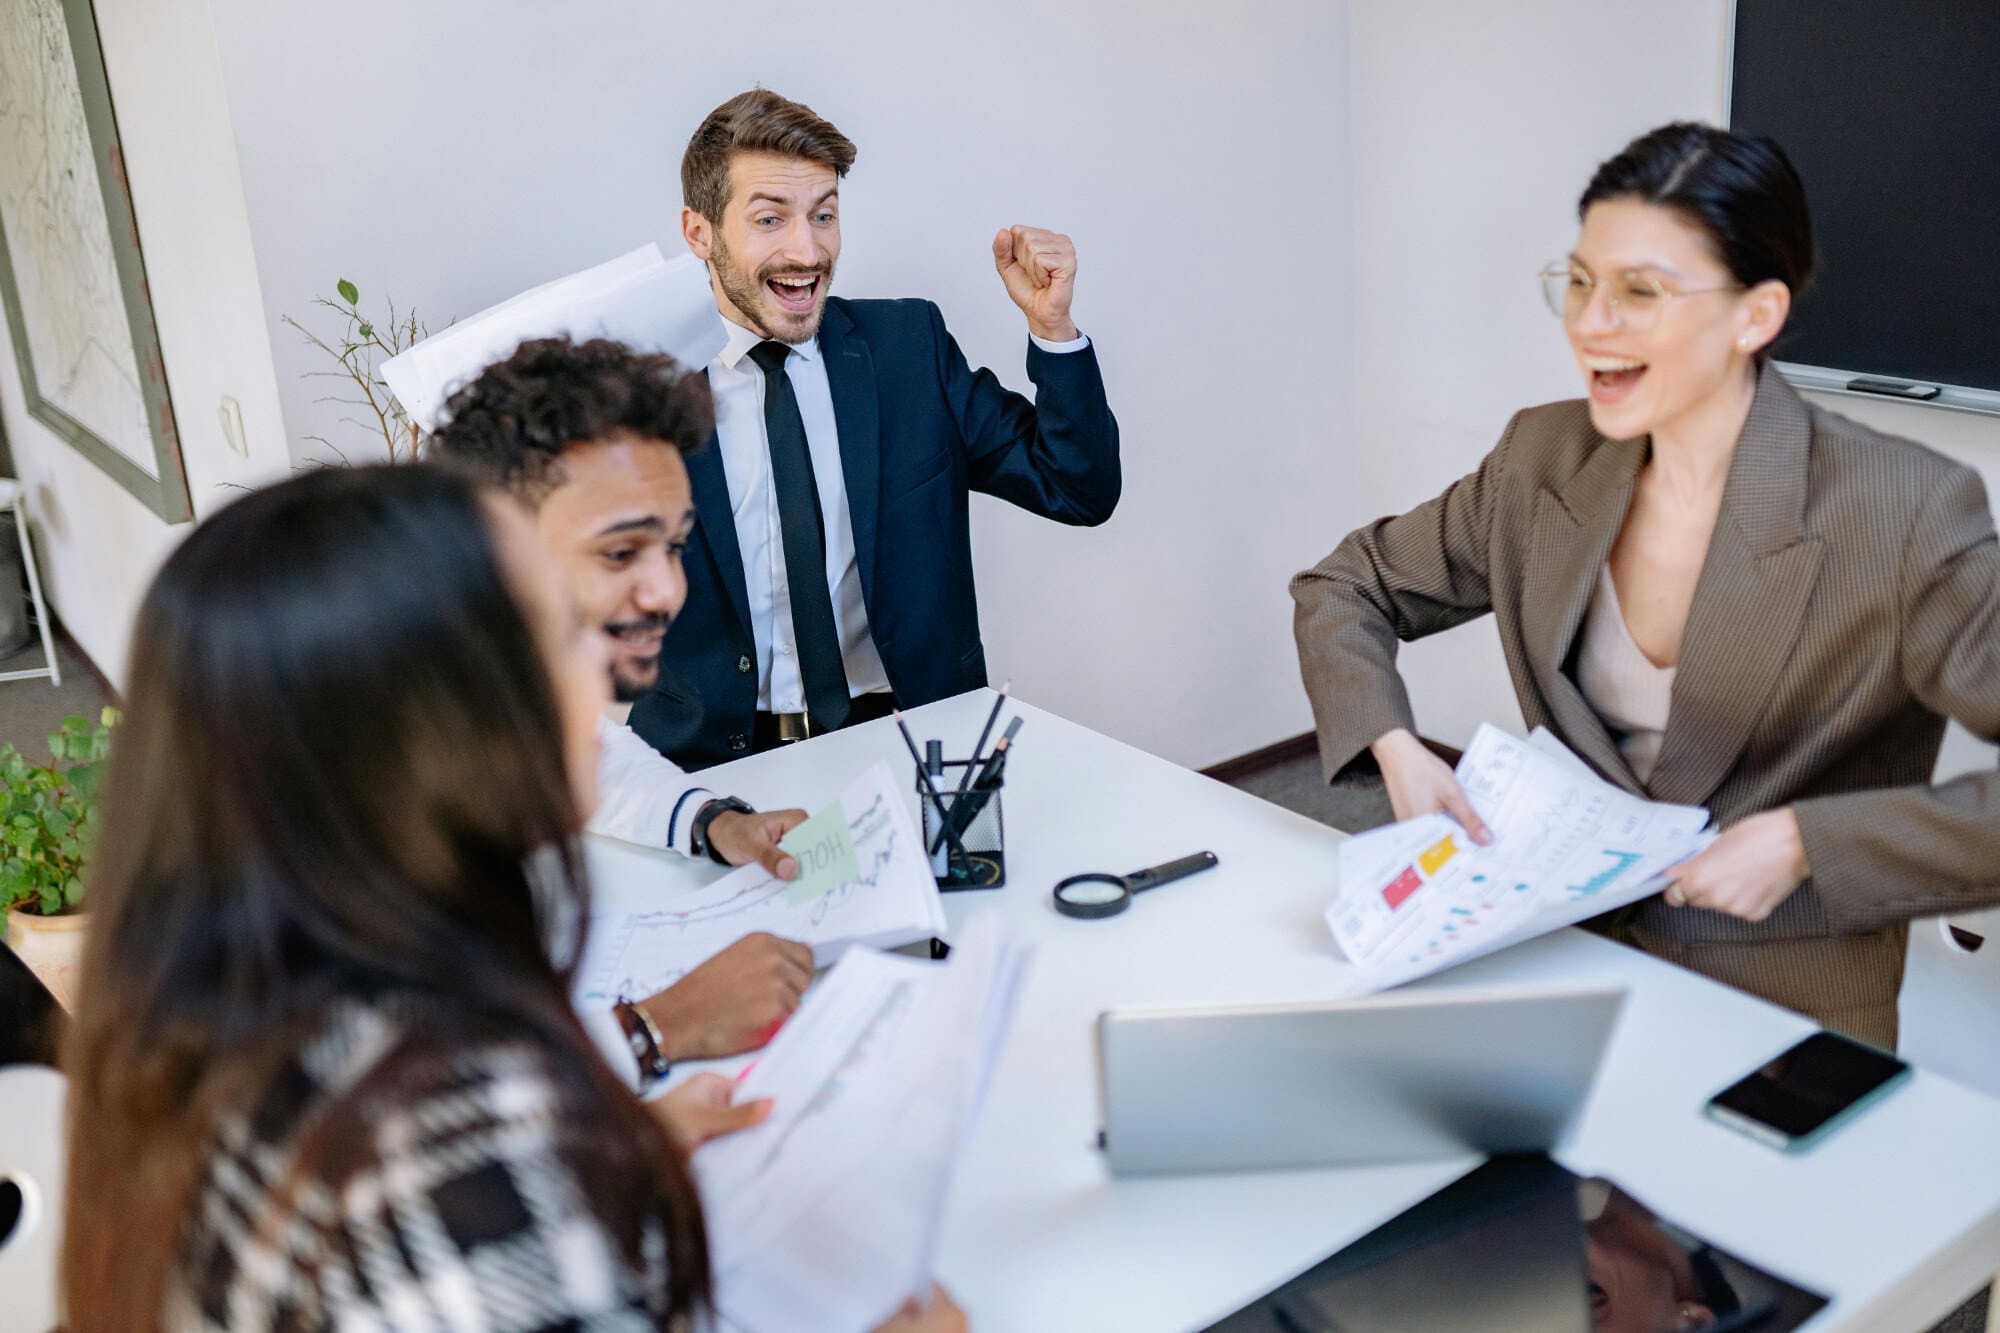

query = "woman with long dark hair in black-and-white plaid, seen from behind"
[62,468,960,1333]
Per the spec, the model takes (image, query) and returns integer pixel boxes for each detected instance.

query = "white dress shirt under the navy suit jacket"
[708,318,1090,713]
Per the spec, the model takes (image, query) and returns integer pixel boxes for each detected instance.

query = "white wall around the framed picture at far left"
[0,0,290,689]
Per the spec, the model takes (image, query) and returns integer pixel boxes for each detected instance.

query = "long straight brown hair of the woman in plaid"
[62,466,710,1333]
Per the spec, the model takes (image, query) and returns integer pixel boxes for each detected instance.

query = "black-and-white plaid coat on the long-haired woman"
[162,1003,688,1333]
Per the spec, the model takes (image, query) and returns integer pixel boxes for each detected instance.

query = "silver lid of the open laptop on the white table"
[1096,987,1624,1175]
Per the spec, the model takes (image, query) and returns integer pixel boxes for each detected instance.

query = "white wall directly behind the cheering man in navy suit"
[214,0,1360,765]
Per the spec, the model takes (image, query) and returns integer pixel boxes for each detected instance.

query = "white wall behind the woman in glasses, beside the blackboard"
[1348,0,2000,769]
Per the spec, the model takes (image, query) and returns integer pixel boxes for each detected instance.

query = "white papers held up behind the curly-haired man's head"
[382,242,728,432]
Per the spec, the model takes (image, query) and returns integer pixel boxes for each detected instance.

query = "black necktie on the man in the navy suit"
[750,342,848,733]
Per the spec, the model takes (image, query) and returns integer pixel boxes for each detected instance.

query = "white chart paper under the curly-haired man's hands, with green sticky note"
[572,763,944,1013]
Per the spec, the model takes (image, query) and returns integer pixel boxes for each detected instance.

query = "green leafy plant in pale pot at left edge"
[0,709,118,1009]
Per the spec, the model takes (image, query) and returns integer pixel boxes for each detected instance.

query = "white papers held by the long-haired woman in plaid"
[694,917,1026,1333]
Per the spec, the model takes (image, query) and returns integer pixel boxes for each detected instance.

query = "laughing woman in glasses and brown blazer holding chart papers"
[1292,124,2000,1045]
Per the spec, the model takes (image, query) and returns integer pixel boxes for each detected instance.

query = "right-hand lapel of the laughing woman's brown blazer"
[1650,366,1824,805]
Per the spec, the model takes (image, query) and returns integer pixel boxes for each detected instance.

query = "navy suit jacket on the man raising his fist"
[630,296,1120,769]
